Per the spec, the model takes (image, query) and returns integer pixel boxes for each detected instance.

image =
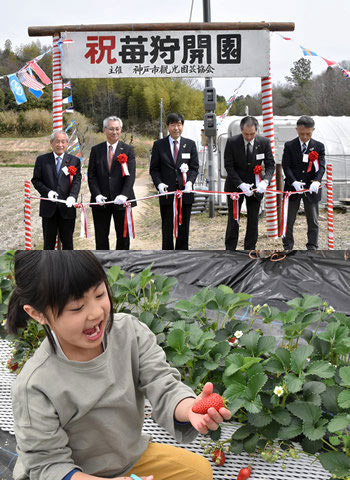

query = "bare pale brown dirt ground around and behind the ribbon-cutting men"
[0,167,350,250]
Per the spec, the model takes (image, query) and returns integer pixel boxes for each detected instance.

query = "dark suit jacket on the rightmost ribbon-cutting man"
[282,137,326,202]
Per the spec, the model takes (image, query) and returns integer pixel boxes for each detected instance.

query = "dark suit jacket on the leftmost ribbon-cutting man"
[32,153,81,219]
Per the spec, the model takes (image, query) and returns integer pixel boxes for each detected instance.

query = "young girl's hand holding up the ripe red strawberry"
[188,382,232,435]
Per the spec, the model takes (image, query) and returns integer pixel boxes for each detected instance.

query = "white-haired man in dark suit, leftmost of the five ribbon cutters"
[32,131,81,250]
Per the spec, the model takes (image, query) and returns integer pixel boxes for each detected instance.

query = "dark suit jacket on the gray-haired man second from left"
[88,140,136,210]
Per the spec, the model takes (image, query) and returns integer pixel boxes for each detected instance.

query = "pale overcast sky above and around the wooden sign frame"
[0,0,350,99]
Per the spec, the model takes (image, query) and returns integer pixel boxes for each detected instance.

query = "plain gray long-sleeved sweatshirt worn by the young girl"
[12,314,197,480]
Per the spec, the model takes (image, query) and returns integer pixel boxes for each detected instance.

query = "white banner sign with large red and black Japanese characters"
[62,30,270,78]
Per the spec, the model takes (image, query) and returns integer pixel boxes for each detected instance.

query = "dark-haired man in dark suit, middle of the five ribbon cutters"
[150,113,199,250]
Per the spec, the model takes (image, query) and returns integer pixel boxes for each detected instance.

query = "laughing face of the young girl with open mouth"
[46,282,111,362]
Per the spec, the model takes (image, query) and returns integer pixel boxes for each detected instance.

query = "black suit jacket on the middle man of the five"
[150,136,199,205]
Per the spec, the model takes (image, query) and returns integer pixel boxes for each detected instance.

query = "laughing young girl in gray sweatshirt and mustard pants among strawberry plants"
[7,250,231,480]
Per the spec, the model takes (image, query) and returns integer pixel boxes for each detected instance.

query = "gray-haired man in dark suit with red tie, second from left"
[88,117,136,250]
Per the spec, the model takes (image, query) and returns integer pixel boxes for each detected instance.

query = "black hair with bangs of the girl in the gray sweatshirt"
[6,250,113,351]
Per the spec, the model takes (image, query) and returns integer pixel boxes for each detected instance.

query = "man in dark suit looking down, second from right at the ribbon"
[224,116,275,250]
